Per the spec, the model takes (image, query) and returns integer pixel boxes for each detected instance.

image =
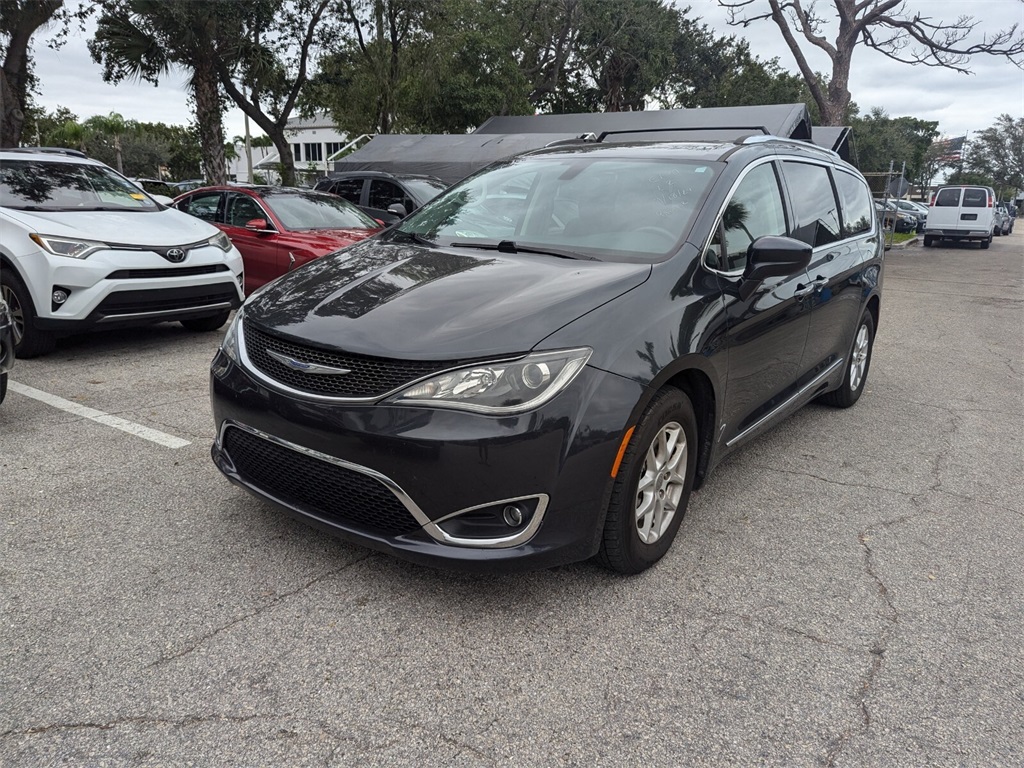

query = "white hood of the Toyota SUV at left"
[3,207,218,246]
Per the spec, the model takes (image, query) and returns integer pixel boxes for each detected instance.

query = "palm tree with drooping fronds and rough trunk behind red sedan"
[89,0,236,183]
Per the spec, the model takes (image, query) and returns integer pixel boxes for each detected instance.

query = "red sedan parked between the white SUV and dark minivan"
[172,186,382,295]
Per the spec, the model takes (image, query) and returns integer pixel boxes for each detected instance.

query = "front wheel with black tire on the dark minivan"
[597,387,698,573]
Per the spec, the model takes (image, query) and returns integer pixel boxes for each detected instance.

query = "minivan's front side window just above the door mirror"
[706,163,785,271]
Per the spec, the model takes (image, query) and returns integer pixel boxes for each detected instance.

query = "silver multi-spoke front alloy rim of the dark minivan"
[635,422,687,544]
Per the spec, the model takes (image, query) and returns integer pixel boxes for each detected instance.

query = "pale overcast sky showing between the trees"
[26,0,1024,141]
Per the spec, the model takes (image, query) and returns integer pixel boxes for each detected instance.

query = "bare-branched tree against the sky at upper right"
[718,0,1024,125]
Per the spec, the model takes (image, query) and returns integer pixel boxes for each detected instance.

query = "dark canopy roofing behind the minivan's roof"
[325,103,849,183]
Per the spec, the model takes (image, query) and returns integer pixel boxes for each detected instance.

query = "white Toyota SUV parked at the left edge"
[0,148,244,357]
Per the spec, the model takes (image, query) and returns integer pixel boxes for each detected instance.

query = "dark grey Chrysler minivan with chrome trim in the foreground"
[211,138,884,572]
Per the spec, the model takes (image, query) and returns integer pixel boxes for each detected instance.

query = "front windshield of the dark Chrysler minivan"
[397,153,719,261]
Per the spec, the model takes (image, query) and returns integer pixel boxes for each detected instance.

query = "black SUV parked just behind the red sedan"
[316,171,447,224]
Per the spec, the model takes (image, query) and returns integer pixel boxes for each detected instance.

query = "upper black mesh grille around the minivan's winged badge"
[243,318,462,397]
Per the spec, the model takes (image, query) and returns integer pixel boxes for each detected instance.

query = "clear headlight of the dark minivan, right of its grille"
[390,347,593,415]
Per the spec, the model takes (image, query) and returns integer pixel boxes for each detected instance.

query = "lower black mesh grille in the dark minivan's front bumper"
[223,427,420,536]
